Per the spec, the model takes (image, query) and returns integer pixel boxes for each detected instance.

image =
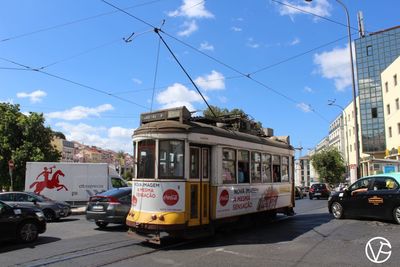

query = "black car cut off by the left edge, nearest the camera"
[0,201,46,243]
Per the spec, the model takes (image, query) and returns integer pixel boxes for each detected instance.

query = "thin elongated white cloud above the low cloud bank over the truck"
[46,104,114,121]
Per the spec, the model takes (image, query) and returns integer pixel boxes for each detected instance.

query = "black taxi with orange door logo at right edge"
[328,172,400,224]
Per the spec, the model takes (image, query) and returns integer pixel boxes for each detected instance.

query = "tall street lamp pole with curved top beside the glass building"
[305,0,360,179]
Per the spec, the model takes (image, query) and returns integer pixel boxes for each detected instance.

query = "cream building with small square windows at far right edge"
[381,57,400,160]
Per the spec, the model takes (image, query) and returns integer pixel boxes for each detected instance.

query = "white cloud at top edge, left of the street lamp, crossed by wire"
[279,0,332,20]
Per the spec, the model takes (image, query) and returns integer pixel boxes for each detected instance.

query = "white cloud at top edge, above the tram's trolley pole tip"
[168,0,214,18]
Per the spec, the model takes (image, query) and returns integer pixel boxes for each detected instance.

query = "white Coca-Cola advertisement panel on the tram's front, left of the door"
[132,181,185,212]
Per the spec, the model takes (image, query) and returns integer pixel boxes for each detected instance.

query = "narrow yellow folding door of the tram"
[187,146,211,226]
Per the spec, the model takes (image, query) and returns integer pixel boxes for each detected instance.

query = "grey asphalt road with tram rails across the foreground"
[0,199,400,267]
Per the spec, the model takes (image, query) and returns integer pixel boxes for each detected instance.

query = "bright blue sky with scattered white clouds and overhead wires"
[0,0,400,156]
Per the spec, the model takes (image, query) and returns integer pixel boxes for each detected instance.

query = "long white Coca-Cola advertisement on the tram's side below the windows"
[216,184,291,218]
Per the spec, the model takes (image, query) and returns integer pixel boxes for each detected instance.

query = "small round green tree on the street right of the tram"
[311,147,346,184]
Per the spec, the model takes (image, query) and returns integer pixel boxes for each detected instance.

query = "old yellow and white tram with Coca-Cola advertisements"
[126,107,294,243]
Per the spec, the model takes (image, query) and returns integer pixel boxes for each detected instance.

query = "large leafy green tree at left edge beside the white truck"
[0,103,61,190]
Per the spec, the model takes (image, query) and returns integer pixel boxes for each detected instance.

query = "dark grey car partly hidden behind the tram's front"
[86,187,132,228]
